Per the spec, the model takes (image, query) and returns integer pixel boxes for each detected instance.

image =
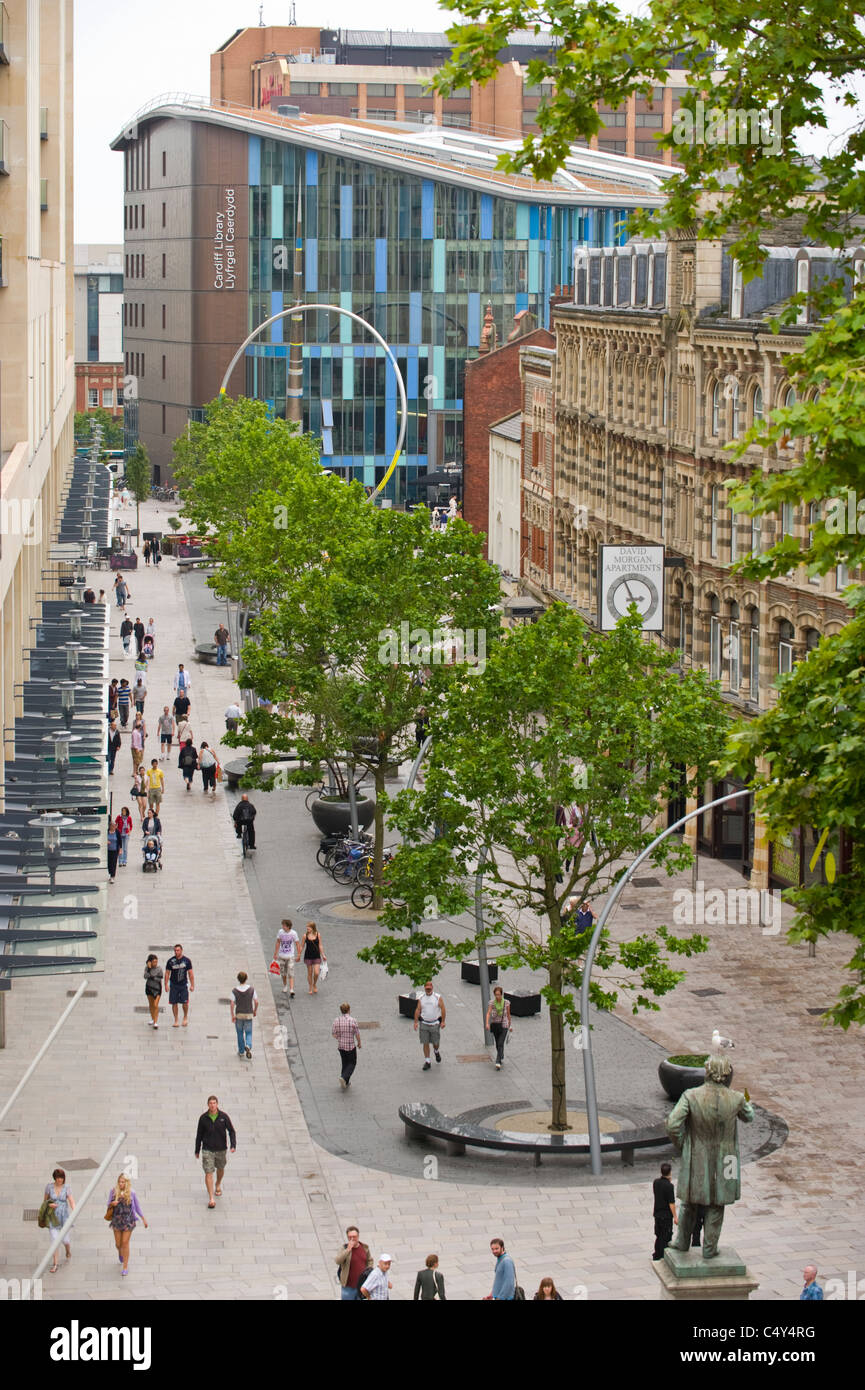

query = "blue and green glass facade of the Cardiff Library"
[246,136,627,500]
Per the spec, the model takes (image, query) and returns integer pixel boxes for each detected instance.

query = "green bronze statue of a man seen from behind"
[666,1056,754,1259]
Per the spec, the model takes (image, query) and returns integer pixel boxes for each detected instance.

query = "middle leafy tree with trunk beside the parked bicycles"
[237,500,499,902]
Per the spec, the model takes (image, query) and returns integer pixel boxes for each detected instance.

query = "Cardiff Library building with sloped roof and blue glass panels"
[113,100,665,502]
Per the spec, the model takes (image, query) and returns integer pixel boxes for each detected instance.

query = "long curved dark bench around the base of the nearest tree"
[399,1101,672,1168]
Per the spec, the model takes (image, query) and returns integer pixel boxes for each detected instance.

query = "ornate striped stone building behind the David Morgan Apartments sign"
[545,228,865,887]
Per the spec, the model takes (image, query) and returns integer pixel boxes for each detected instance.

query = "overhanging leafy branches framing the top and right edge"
[435,0,865,1026]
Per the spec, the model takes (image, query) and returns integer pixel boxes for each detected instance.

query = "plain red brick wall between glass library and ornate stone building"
[463,328,556,553]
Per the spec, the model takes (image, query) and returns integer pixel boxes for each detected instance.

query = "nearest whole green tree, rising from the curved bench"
[360,603,729,1130]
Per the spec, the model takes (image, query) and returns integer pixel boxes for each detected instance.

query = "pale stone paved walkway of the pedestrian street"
[0,505,865,1301]
